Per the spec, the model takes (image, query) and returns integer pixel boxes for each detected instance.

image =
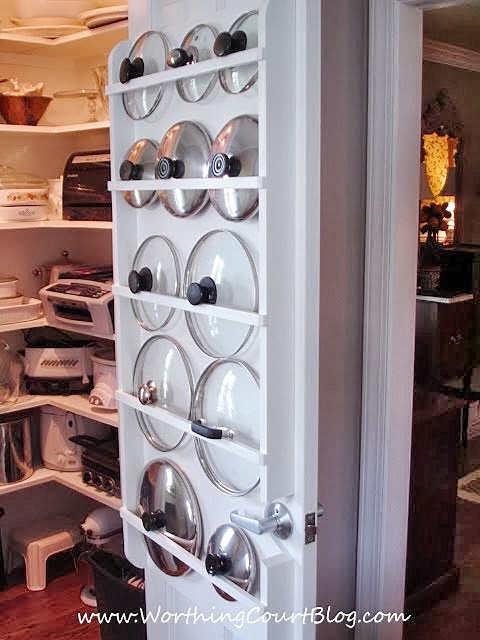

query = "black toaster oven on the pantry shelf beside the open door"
[63,150,112,220]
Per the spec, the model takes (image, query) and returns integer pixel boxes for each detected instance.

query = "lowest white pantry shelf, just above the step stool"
[0,467,122,511]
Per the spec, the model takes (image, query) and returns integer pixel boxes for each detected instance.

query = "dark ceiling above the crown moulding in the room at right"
[423,0,480,52]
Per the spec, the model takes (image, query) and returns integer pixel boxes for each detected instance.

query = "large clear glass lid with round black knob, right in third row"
[183,229,258,358]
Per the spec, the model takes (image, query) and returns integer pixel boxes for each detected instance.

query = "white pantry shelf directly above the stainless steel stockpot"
[0,394,118,427]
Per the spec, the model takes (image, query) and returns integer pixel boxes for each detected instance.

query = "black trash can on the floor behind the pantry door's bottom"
[85,549,147,640]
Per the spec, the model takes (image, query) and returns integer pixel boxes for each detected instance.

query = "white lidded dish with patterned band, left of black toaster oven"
[0,165,48,222]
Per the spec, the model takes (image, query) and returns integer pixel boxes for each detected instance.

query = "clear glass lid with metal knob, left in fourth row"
[133,336,193,451]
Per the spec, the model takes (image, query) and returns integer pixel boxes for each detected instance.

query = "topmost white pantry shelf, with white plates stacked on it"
[0,20,128,60]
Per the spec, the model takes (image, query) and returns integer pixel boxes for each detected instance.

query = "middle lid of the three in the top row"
[167,24,217,102]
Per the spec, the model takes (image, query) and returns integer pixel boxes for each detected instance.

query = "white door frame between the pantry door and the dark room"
[355,0,461,640]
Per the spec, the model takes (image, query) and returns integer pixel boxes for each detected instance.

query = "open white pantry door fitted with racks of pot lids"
[107,0,320,640]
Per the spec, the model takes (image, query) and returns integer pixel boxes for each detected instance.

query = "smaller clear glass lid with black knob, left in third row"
[128,236,180,331]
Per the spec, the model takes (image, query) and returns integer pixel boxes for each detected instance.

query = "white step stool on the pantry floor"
[8,516,83,591]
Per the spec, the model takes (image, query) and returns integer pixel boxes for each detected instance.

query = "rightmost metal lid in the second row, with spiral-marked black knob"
[208,115,258,221]
